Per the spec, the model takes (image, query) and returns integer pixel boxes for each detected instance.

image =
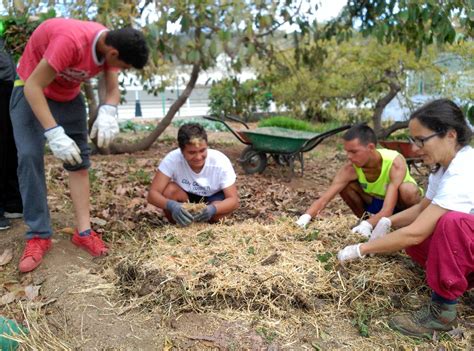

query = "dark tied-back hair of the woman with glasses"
[410,99,472,146]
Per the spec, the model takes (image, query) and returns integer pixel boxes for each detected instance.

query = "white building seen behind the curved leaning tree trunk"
[118,56,256,120]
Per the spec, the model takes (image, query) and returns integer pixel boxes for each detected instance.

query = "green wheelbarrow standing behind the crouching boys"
[204,116,351,175]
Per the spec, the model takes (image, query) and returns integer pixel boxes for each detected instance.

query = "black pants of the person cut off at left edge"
[0,81,23,216]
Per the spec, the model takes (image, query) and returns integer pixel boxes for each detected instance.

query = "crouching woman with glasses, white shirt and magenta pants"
[338,99,474,337]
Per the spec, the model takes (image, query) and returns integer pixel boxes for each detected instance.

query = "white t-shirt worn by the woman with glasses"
[426,146,474,214]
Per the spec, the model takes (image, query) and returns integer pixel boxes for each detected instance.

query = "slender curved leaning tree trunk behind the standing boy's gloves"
[110,63,201,154]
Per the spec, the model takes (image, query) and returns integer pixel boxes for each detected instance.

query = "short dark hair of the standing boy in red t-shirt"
[105,27,149,69]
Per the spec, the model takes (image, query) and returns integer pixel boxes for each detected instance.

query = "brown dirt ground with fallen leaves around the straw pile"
[0,128,474,350]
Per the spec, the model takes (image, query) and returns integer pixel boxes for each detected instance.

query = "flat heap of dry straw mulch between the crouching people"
[116,216,423,316]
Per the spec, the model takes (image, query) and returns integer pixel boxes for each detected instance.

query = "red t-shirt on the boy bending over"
[17,18,115,101]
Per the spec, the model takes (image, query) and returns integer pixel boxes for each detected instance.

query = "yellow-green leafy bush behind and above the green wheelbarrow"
[259,36,440,123]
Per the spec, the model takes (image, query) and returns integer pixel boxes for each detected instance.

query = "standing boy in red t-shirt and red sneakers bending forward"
[10,18,148,272]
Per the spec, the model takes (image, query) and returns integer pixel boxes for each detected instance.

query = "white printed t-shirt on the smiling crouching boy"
[158,148,237,196]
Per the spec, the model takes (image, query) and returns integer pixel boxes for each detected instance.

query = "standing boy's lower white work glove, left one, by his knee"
[44,126,82,166]
